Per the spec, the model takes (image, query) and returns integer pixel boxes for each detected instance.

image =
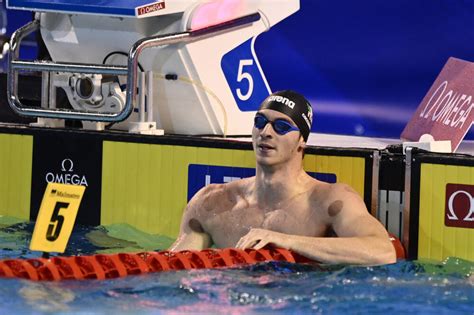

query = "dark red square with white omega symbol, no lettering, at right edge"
[444,184,474,228]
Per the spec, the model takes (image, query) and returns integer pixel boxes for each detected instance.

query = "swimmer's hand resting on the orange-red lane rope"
[235,229,289,249]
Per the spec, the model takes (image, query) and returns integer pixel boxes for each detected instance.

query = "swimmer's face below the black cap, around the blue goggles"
[252,109,304,165]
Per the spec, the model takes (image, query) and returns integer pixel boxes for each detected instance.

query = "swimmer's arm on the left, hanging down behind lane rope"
[169,187,212,251]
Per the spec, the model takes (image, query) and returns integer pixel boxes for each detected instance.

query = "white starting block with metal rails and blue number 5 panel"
[7,0,299,136]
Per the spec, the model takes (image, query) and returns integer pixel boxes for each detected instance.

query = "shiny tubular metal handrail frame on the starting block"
[7,13,260,122]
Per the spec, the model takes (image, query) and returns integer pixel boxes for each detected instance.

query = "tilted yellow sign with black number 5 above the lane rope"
[30,183,86,253]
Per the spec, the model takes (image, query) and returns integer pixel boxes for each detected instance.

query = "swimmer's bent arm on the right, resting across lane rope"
[236,185,396,265]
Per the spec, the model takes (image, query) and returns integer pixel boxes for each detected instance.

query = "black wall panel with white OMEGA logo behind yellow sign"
[30,132,102,225]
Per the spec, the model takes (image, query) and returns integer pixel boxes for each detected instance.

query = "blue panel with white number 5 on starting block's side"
[221,37,271,111]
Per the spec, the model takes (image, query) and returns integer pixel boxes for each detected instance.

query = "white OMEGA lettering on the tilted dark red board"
[420,81,474,129]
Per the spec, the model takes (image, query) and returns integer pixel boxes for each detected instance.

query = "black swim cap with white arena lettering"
[259,90,313,142]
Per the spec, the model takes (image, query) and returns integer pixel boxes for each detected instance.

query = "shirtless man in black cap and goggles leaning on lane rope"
[171,91,396,265]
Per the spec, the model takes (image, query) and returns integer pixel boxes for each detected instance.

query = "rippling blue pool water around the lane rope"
[0,218,474,314]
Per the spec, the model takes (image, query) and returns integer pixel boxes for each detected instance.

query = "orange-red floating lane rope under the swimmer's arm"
[0,236,405,281]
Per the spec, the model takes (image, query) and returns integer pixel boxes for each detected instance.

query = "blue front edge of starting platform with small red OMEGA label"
[7,0,165,17]
